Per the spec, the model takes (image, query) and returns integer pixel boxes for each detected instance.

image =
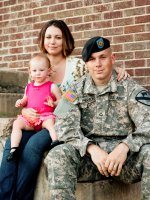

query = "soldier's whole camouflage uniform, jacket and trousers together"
[46,73,150,200]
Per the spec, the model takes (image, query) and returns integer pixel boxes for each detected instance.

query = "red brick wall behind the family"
[0,0,150,89]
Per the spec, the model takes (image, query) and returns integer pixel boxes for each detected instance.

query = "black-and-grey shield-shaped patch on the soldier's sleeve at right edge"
[135,90,150,106]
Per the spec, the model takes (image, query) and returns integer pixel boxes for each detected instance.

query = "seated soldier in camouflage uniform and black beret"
[46,37,150,200]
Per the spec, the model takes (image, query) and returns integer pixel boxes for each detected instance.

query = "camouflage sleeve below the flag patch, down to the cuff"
[54,91,91,156]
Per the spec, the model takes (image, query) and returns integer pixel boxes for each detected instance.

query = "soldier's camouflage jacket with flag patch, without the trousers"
[55,72,150,156]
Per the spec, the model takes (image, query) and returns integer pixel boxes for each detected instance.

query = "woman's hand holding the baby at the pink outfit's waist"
[22,108,40,123]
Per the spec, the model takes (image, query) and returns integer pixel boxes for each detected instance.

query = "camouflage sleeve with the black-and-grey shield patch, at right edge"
[123,86,150,152]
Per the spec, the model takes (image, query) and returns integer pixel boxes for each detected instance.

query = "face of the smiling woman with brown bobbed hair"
[44,26,63,56]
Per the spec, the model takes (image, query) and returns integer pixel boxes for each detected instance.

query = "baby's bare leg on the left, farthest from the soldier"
[11,118,34,148]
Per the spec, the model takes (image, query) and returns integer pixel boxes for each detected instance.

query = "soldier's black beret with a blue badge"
[82,36,110,62]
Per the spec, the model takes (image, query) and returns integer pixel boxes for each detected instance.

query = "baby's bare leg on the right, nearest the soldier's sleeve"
[42,118,58,141]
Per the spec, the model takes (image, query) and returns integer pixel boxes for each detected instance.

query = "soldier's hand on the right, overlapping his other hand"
[105,143,129,176]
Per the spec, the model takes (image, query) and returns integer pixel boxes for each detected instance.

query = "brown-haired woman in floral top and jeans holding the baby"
[0,20,127,200]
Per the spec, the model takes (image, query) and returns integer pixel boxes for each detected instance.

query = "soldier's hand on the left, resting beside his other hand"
[87,144,109,177]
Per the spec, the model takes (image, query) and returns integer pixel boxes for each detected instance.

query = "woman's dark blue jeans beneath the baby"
[0,129,52,200]
